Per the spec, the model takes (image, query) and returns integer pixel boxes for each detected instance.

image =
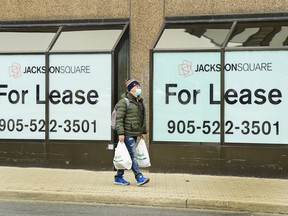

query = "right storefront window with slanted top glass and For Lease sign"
[151,19,288,144]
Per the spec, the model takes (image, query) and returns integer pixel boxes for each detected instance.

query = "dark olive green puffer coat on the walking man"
[116,92,147,136]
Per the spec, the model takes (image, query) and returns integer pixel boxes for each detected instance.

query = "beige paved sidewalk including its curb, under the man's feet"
[0,167,288,214]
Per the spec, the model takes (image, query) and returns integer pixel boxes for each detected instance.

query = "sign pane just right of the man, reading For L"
[153,52,220,142]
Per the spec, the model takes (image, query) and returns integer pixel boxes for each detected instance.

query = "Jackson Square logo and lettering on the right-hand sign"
[178,60,272,77]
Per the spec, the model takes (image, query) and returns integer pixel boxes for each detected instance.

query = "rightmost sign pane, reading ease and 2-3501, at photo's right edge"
[225,51,288,144]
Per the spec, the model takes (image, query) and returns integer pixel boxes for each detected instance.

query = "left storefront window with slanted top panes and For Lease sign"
[0,21,129,141]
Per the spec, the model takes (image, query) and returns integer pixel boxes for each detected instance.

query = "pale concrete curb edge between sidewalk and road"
[0,190,288,214]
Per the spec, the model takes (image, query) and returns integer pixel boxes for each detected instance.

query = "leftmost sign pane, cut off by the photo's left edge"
[0,55,45,139]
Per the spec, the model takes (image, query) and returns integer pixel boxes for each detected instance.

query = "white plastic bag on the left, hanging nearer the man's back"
[113,141,132,170]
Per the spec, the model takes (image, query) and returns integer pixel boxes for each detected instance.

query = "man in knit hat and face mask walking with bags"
[114,78,150,186]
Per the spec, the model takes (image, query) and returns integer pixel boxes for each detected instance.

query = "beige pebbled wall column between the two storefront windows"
[130,0,164,135]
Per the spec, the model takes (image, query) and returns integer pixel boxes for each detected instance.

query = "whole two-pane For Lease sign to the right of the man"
[153,51,288,144]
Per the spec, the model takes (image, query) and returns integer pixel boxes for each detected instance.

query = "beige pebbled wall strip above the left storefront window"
[0,0,130,20]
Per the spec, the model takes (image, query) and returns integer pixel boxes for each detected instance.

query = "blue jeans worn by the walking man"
[115,136,142,179]
